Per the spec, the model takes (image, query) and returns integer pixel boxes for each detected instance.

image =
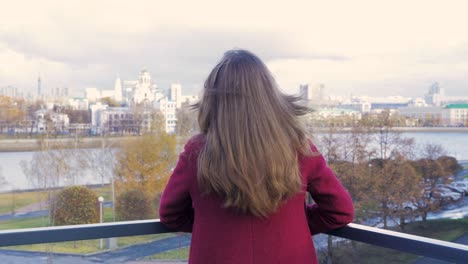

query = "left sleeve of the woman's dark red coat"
[159,144,196,232]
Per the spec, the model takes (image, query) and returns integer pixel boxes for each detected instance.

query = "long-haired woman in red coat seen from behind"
[159,50,353,264]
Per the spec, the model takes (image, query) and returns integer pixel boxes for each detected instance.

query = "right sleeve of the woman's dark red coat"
[303,146,354,235]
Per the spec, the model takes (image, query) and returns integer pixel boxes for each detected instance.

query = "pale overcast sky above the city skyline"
[0,0,468,96]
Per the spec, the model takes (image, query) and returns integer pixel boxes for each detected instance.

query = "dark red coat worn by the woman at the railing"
[159,137,353,264]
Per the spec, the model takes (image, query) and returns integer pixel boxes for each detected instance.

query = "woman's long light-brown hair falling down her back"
[196,50,311,217]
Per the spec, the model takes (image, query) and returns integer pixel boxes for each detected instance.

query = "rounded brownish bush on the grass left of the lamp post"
[51,186,99,225]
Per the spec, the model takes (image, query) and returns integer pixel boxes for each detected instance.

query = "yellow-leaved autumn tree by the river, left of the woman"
[115,132,177,196]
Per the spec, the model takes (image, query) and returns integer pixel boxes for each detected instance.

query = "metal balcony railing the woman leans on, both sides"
[0,220,468,263]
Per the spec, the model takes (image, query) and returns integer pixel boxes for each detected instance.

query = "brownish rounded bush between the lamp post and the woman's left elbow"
[115,189,155,221]
